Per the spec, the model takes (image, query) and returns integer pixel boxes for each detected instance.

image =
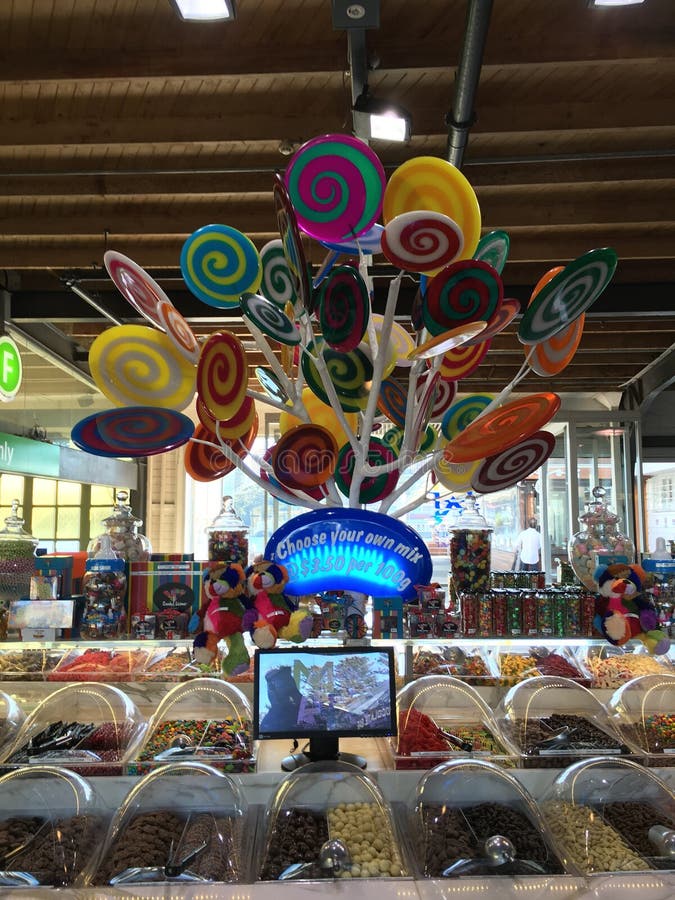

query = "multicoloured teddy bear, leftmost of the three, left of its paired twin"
[193,562,250,675]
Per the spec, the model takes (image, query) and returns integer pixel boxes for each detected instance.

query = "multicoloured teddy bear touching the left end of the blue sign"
[243,559,312,649]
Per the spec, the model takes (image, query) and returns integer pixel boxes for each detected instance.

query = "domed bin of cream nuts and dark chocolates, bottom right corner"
[540,757,675,876]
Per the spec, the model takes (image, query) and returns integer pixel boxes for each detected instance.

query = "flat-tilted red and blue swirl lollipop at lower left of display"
[71,406,194,457]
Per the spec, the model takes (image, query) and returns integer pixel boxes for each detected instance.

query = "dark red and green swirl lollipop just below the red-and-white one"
[422,259,504,334]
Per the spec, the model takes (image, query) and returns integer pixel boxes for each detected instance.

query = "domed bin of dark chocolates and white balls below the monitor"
[256,762,408,881]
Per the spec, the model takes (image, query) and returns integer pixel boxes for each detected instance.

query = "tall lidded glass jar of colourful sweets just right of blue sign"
[450,492,492,594]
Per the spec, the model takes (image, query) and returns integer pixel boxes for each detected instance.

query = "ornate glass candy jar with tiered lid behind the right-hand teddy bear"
[568,487,635,591]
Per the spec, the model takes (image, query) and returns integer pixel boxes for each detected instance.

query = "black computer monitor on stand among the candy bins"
[253,647,396,772]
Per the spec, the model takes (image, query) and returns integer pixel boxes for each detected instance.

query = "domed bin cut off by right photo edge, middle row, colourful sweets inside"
[607,675,675,766]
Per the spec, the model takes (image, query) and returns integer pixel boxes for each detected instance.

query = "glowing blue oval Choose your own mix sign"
[265,509,433,600]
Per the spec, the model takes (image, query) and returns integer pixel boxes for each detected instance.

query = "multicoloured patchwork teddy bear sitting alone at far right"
[593,563,670,654]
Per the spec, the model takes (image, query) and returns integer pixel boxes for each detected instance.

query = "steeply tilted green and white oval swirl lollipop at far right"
[518,247,617,344]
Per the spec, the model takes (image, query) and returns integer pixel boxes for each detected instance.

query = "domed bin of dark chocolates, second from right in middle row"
[495,676,630,769]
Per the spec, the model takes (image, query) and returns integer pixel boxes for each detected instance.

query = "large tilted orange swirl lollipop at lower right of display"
[444,391,560,462]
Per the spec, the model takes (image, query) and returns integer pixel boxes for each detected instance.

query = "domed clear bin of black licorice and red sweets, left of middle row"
[2,683,147,777]
